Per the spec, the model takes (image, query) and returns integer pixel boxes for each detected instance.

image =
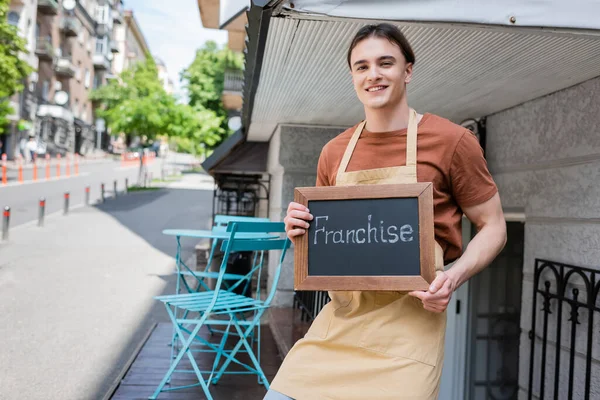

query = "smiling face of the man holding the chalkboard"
[350,37,412,109]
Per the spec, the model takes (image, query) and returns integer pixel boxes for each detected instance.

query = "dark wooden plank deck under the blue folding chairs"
[112,323,281,400]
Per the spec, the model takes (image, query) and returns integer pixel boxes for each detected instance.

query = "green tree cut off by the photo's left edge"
[0,0,33,133]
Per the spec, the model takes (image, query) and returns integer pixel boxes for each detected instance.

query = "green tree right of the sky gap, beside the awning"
[181,41,243,149]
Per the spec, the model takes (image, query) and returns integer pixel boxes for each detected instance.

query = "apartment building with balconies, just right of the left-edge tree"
[34,0,123,154]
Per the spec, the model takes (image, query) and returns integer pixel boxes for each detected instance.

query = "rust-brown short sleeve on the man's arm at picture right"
[450,131,498,208]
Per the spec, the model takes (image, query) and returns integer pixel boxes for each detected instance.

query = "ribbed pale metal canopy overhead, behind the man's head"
[244,0,600,141]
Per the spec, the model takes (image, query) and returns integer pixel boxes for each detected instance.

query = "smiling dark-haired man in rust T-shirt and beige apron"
[265,24,506,400]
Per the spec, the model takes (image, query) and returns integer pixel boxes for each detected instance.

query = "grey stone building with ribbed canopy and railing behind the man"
[199,1,600,400]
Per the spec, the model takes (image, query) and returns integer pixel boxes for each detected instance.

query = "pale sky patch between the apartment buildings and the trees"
[124,0,227,99]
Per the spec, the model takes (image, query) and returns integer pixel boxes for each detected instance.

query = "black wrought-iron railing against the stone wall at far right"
[528,259,600,399]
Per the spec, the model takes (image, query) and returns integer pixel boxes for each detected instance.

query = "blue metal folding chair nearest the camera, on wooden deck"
[150,222,290,400]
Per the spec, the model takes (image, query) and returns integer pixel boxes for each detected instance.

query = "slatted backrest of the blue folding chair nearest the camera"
[222,222,291,306]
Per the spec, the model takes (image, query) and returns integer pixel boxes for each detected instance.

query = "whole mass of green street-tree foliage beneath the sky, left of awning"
[90,42,242,154]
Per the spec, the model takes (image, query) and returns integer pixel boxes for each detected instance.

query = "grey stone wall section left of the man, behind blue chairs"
[268,125,346,307]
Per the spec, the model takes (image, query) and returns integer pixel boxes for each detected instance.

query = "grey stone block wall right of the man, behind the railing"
[486,78,600,399]
